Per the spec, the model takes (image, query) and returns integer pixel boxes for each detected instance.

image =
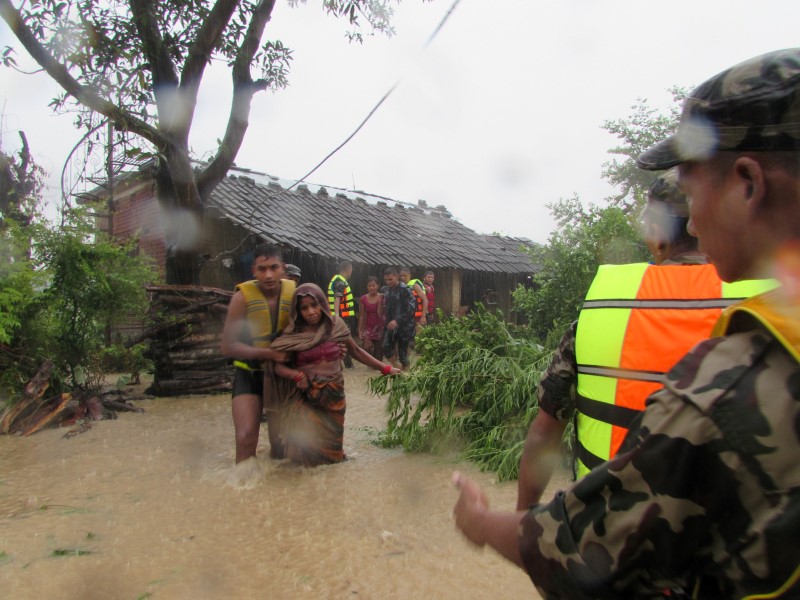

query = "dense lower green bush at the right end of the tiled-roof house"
[512,197,648,348]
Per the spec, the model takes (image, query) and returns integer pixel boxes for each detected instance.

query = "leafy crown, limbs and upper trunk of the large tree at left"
[0,0,412,283]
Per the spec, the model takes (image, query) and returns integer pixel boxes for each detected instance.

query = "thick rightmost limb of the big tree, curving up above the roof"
[197,0,275,199]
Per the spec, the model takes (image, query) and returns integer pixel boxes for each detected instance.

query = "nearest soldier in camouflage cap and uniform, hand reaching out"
[453,49,800,599]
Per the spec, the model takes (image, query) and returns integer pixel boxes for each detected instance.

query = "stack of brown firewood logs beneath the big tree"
[138,285,233,396]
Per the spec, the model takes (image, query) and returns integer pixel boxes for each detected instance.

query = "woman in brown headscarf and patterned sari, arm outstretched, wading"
[266,283,400,467]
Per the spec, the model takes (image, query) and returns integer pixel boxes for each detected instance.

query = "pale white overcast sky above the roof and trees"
[0,0,800,242]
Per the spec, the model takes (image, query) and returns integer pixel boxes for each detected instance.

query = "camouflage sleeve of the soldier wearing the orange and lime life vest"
[538,321,578,423]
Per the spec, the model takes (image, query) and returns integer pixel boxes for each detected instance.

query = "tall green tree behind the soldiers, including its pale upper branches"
[513,92,687,347]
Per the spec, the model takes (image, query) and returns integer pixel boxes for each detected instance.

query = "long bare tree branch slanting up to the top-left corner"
[0,0,167,148]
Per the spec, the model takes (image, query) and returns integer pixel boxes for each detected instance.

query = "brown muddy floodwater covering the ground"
[0,365,563,600]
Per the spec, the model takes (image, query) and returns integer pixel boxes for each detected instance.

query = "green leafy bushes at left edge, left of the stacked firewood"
[0,199,158,397]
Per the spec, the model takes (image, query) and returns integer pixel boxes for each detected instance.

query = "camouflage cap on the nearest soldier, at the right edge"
[636,48,800,171]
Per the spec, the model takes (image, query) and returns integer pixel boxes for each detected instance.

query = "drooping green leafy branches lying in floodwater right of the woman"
[370,304,548,480]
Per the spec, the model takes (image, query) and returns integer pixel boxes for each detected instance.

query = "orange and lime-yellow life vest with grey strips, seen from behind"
[575,263,776,476]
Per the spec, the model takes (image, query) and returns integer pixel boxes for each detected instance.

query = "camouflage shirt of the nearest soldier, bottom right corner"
[519,316,800,599]
